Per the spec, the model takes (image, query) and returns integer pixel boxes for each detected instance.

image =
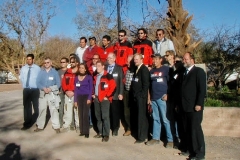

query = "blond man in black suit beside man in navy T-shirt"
[131,53,150,144]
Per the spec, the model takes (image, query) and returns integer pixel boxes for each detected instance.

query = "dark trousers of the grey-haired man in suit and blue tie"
[110,100,122,131]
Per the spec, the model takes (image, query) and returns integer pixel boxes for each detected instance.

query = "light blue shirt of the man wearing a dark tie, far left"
[20,64,41,88]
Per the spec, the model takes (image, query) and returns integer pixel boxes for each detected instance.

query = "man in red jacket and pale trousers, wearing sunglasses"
[62,56,80,132]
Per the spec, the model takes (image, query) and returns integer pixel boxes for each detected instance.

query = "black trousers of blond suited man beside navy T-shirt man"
[134,97,148,141]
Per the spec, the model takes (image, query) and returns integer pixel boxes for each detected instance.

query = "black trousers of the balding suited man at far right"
[183,110,205,158]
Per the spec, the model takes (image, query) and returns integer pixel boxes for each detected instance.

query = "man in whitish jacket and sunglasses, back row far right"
[153,29,175,56]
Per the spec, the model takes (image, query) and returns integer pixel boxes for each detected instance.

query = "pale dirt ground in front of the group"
[0,84,240,160]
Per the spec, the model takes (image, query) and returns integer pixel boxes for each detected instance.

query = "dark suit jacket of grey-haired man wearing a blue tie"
[105,64,124,100]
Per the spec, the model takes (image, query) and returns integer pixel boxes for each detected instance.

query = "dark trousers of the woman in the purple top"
[77,95,91,134]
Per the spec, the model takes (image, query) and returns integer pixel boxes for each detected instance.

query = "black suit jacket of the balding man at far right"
[181,66,207,112]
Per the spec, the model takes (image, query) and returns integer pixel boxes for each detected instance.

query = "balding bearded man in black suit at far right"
[181,52,206,160]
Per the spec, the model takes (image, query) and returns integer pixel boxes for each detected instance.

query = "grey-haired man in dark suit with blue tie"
[105,53,124,136]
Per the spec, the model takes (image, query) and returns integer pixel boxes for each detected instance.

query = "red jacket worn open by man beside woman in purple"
[94,71,116,102]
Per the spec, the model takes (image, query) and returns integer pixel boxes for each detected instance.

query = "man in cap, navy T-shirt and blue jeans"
[146,54,173,148]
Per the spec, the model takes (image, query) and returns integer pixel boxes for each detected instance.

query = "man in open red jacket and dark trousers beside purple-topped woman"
[92,61,116,142]
